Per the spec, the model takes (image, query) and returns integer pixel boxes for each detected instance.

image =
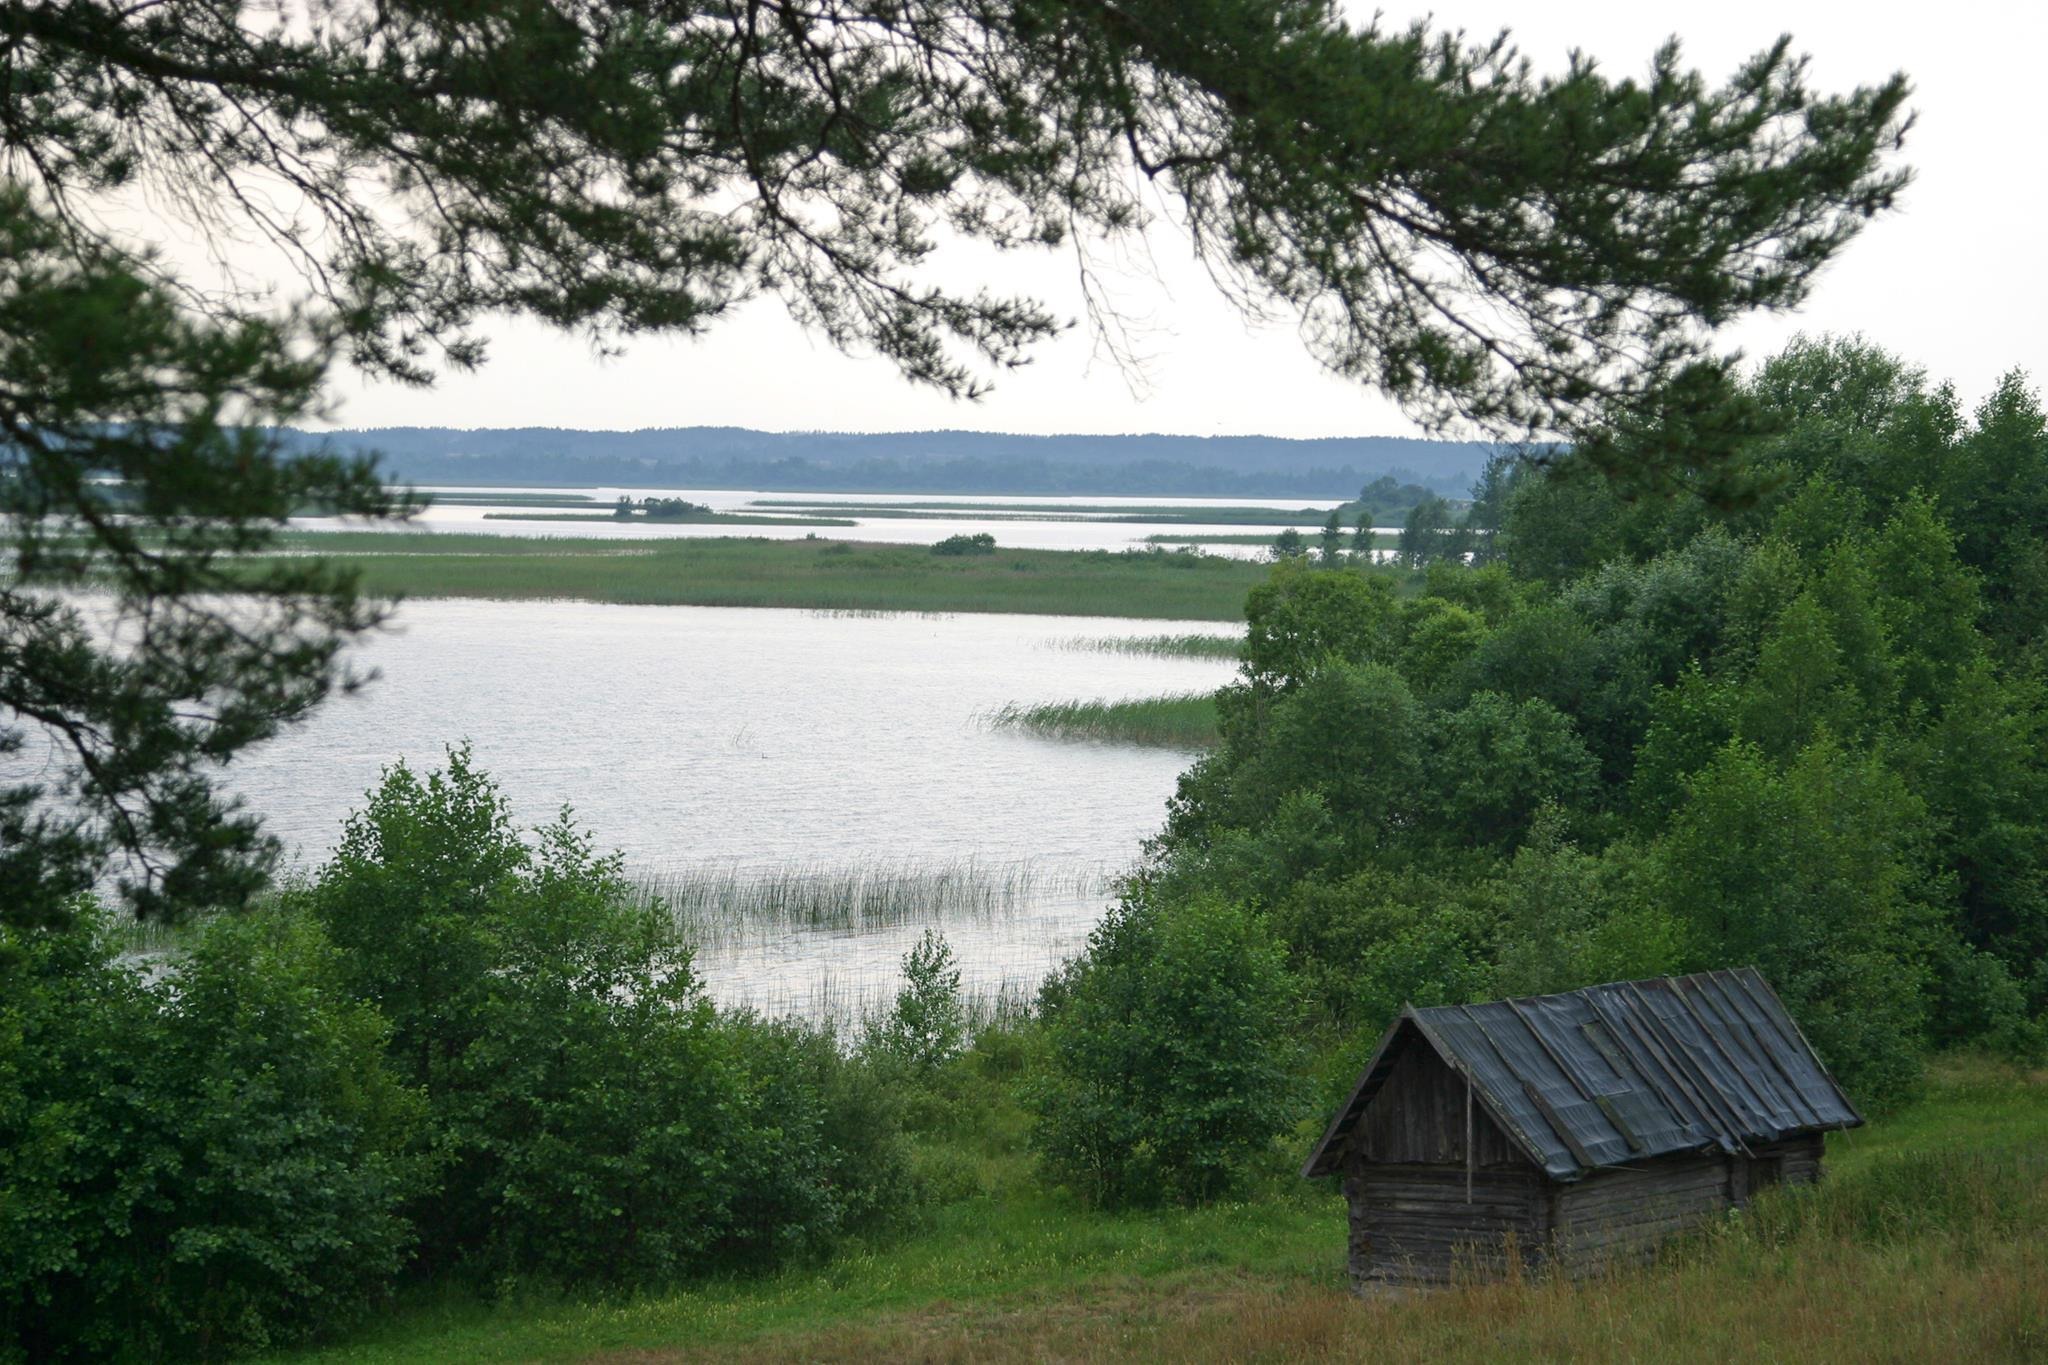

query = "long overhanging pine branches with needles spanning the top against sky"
[12,0,1907,454]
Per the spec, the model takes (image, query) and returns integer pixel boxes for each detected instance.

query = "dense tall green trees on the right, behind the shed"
[1133,342,2048,1103]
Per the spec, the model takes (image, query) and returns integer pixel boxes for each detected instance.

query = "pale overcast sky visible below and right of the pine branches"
[323,0,2048,436]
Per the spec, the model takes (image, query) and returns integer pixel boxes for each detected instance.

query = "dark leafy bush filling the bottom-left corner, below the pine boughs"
[0,911,424,1359]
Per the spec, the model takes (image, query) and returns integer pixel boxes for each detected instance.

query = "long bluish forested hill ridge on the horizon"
[291,426,1493,497]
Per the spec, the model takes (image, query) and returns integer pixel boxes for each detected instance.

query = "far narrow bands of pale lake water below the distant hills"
[293,487,1392,559]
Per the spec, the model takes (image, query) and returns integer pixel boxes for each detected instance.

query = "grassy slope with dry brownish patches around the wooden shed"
[276,1060,2048,1365]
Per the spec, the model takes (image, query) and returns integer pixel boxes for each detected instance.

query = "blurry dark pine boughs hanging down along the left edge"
[0,189,406,923]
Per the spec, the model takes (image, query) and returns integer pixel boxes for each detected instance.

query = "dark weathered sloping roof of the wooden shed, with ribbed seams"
[1303,968,1864,1181]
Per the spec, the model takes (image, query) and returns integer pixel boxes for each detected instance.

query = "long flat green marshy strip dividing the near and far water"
[268,532,1266,620]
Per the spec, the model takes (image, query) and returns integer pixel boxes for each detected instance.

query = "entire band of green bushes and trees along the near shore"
[16,342,2048,1359]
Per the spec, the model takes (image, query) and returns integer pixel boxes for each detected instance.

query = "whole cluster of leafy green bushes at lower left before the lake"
[0,749,915,1359]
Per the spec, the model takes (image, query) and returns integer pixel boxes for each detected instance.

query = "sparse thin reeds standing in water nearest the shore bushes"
[639,857,1108,950]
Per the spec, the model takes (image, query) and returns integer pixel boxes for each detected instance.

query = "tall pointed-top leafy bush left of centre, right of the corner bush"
[309,749,907,1285]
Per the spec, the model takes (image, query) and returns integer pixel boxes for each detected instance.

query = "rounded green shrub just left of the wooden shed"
[1032,900,1305,1205]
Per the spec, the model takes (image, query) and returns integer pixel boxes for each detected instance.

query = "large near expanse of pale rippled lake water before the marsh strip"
[231,602,1233,1013]
